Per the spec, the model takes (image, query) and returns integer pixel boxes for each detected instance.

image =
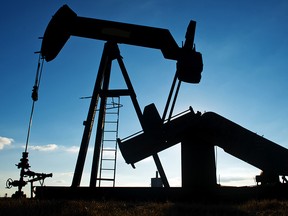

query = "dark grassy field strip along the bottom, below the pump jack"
[0,198,288,216]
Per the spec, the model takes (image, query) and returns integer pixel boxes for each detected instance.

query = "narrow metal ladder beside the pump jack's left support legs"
[97,97,122,187]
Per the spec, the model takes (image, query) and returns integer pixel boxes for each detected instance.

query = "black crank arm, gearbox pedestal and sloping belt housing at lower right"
[119,109,288,188]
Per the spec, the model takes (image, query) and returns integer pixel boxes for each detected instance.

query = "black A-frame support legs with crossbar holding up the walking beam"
[71,41,169,187]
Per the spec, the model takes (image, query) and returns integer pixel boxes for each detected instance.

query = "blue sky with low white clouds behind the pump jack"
[0,0,288,197]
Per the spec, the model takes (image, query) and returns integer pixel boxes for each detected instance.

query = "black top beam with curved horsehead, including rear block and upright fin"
[41,5,203,83]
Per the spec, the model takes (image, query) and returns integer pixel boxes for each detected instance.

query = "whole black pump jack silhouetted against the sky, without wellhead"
[38,5,288,198]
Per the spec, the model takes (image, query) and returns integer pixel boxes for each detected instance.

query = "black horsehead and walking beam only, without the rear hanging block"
[41,5,179,61]
